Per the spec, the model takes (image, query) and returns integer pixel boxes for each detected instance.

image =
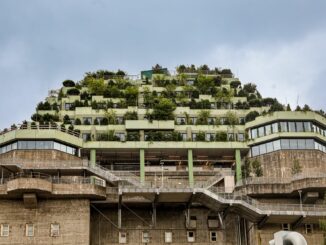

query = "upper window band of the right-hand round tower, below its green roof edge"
[249,121,326,139]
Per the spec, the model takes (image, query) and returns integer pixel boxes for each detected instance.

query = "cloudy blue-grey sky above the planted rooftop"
[0,0,326,129]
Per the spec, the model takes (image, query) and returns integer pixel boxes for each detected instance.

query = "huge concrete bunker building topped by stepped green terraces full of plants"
[0,66,326,245]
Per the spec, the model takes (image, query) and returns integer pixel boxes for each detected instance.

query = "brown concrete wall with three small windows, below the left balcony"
[0,199,90,245]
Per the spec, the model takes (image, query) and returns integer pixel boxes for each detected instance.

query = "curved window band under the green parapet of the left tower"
[0,140,77,155]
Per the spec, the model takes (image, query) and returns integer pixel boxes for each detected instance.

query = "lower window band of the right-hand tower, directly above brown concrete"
[251,139,326,157]
